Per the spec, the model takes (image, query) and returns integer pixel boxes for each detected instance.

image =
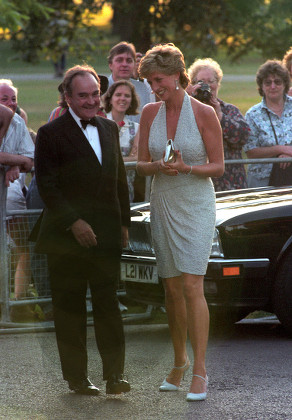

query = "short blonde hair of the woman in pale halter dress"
[138,44,189,89]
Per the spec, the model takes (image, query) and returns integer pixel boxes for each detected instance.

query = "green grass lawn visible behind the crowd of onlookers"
[0,41,262,131]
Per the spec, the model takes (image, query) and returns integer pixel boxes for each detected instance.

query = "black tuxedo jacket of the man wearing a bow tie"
[31,112,130,255]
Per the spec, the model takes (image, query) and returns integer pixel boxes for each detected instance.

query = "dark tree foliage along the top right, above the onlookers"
[107,0,292,59]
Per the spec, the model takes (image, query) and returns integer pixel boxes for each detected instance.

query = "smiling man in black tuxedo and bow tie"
[32,66,130,395]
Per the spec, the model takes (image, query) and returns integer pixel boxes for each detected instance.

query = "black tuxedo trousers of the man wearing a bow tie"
[48,254,125,382]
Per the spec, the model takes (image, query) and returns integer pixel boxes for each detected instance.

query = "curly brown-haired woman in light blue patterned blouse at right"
[244,60,292,187]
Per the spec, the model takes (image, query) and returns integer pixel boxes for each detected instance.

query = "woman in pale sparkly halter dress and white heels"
[137,44,224,401]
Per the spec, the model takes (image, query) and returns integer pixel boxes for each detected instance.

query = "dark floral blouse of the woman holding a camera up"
[213,99,250,191]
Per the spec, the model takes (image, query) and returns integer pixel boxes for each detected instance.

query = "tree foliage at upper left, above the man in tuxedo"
[4,0,101,68]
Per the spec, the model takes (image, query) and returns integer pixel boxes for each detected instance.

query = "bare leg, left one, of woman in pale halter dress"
[163,277,187,386]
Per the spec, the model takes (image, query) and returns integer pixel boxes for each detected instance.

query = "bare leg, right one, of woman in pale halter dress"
[183,273,209,393]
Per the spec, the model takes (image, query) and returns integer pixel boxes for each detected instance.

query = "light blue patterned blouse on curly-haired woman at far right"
[244,95,292,179]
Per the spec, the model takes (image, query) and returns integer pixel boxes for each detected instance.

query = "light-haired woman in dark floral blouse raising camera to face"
[187,58,249,191]
